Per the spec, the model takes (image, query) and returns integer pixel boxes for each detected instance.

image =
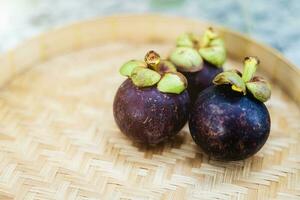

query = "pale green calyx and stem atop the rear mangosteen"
[170,28,226,72]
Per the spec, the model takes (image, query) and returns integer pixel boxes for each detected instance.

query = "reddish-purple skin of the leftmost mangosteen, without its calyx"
[113,79,190,145]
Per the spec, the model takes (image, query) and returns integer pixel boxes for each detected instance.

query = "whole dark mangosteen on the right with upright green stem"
[189,57,271,161]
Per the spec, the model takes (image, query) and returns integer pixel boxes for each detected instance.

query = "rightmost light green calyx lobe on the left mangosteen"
[157,72,187,94]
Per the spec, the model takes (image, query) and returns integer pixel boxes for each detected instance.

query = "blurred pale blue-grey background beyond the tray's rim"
[0,0,300,67]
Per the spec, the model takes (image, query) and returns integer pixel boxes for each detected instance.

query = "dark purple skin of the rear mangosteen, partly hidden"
[181,61,223,102]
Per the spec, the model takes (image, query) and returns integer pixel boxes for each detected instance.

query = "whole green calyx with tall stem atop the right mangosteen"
[213,57,271,102]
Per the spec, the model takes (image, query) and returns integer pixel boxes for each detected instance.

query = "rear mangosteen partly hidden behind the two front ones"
[169,28,226,102]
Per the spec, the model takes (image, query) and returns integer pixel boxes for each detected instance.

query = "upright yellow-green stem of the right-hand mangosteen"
[242,56,259,83]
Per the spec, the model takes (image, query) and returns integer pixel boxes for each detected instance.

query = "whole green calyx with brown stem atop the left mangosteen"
[120,51,187,94]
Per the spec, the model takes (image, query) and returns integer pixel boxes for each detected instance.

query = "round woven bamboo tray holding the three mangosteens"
[0,15,300,200]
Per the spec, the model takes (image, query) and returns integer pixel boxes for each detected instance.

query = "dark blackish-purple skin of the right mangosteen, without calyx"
[189,85,271,161]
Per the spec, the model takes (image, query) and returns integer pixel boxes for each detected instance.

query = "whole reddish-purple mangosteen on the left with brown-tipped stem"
[113,51,190,145]
